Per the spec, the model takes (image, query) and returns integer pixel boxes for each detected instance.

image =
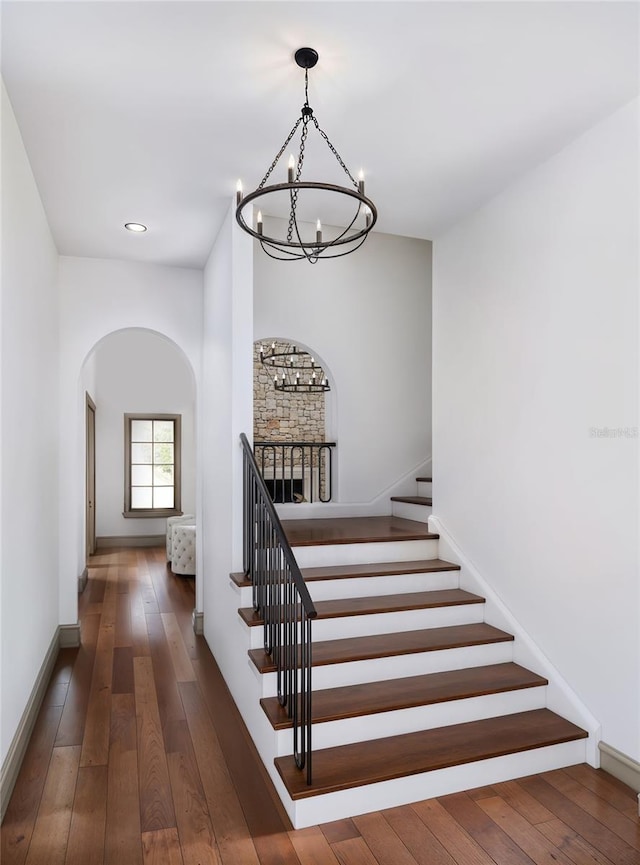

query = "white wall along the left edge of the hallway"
[0,85,60,762]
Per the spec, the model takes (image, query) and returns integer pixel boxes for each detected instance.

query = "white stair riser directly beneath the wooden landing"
[293,538,438,568]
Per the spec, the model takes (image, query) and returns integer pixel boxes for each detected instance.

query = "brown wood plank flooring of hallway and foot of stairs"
[0,548,640,865]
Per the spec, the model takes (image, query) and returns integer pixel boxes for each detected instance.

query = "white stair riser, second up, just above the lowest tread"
[277,686,546,756]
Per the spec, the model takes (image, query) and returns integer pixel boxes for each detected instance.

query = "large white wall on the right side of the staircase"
[433,103,640,759]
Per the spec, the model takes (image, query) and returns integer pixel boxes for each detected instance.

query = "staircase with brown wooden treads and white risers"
[232,478,588,828]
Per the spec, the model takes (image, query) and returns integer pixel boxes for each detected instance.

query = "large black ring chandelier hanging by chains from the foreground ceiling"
[236,48,378,264]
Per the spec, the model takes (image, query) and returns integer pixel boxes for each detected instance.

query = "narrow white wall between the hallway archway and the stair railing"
[199,201,253,668]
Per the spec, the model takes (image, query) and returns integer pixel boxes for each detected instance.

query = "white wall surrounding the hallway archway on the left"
[59,256,202,623]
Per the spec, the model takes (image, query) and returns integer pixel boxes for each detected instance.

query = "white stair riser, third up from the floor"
[260,640,513,697]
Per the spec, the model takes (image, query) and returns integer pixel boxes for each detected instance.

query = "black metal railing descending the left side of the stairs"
[240,433,317,784]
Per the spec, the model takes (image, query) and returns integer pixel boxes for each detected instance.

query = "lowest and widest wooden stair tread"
[275,709,588,799]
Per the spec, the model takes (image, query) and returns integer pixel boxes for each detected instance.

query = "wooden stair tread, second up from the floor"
[260,663,548,730]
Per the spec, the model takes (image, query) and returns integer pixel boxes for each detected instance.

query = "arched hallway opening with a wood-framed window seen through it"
[80,328,196,572]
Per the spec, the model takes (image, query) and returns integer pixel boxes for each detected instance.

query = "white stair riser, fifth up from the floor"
[238,571,460,607]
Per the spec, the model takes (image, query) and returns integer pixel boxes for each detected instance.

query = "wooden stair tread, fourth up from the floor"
[238,589,485,627]
